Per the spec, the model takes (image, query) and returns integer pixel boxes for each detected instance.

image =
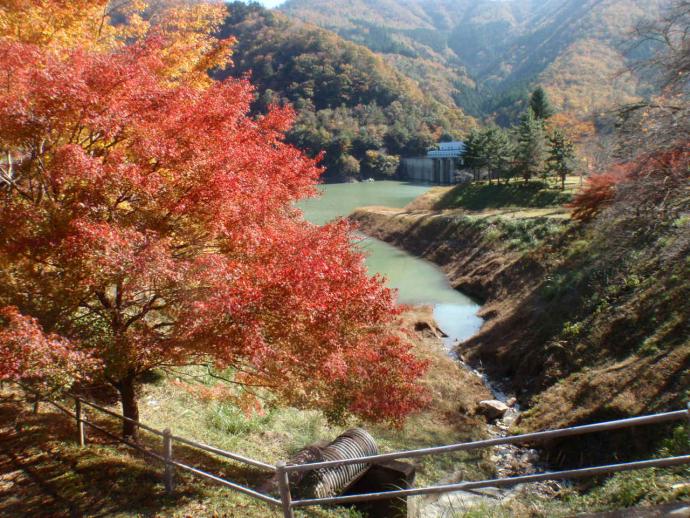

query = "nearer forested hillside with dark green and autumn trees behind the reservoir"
[215,2,474,180]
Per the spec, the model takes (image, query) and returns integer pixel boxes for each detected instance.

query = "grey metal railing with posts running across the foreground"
[18,388,690,518]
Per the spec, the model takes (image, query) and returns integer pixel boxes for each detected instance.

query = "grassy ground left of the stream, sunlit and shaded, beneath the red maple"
[0,310,493,518]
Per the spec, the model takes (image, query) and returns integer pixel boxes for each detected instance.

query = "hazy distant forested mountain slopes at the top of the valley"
[282,0,669,122]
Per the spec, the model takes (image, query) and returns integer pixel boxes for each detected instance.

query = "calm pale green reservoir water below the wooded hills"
[300,181,483,345]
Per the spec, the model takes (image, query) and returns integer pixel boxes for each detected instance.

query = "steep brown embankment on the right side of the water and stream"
[352,185,690,470]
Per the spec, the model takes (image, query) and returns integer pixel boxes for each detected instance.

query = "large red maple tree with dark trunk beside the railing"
[0,38,425,436]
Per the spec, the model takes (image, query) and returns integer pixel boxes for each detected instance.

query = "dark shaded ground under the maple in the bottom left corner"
[0,394,274,517]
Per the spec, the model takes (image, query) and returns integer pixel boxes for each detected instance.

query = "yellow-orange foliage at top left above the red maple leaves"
[0,0,234,87]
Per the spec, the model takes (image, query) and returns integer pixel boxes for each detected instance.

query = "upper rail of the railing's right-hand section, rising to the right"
[285,410,688,472]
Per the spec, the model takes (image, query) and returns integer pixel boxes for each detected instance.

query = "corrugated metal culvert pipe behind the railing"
[297,428,379,498]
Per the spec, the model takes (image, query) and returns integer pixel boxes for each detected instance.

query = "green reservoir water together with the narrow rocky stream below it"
[299,181,538,518]
